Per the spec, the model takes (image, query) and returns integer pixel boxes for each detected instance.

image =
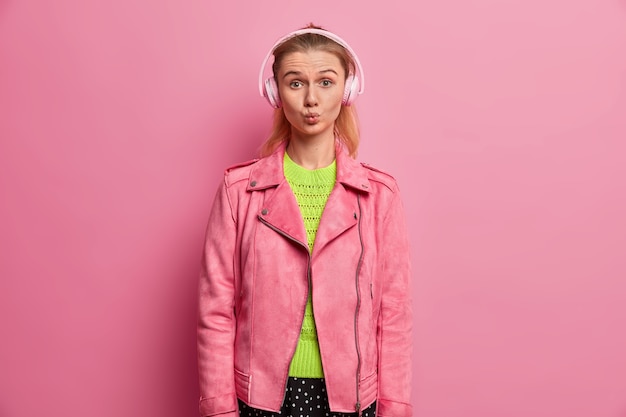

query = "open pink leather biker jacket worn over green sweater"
[198,145,412,417]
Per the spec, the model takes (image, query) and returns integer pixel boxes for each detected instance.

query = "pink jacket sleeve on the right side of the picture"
[376,188,413,417]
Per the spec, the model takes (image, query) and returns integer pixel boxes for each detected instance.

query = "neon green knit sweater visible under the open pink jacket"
[283,152,337,378]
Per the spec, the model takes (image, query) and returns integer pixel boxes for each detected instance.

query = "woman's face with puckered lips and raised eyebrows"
[277,50,345,145]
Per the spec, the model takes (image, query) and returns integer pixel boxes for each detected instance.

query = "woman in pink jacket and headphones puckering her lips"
[198,26,412,417]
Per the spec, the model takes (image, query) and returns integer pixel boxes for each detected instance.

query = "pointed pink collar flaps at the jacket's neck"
[247,141,370,193]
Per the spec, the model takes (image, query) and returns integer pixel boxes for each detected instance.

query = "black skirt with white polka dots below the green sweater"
[239,378,376,417]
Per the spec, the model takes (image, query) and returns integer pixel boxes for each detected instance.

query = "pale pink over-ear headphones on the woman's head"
[259,28,365,109]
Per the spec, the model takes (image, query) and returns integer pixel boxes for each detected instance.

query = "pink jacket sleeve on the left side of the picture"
[197,179,238,417]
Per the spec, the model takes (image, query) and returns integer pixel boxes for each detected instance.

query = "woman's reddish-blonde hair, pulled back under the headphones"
[260,24,360,158]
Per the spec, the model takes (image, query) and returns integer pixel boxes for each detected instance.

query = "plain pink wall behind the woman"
[0,0,626,417]
